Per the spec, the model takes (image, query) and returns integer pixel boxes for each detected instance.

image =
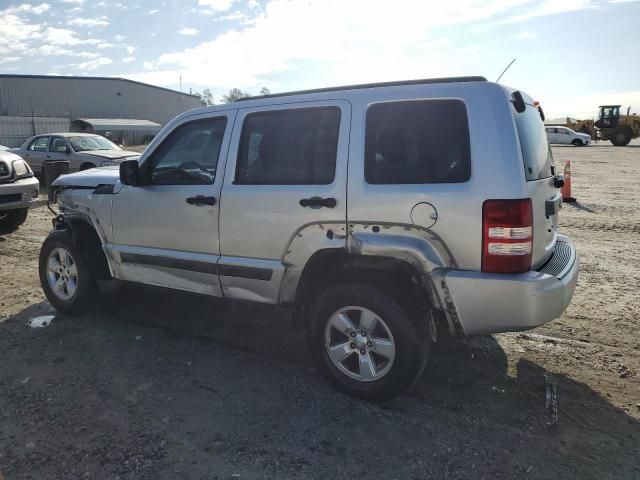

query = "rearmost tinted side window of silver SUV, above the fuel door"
[365,100,471,184]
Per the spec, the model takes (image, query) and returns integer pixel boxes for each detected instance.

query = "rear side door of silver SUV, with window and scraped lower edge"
[219,101,351,303]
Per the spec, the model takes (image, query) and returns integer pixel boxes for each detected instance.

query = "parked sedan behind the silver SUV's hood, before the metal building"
[12,133,140,176]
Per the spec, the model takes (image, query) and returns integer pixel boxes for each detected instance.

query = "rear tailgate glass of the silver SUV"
[514,105,553,181]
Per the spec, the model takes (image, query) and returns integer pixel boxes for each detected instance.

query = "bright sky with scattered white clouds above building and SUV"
[0,0,640,118]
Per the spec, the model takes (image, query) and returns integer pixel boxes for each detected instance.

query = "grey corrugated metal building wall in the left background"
[0,75,200,125]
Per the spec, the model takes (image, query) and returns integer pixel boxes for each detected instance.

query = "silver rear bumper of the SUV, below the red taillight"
[445,236,579,335]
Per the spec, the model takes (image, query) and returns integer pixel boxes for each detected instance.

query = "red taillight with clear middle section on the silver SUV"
[482,198,533,273]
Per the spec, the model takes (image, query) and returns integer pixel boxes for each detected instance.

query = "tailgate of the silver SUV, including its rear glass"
[512,105,556,268]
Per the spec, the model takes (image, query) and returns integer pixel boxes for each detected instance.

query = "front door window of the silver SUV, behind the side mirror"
[150,117,227,185]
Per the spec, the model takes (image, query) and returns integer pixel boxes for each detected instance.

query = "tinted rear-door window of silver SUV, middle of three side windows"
[235,107,340,185]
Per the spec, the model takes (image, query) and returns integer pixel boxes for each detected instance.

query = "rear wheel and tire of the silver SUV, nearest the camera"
[307,283,430,401]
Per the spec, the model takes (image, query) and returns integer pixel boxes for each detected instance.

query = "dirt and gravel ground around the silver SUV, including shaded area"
[0,141,640,480]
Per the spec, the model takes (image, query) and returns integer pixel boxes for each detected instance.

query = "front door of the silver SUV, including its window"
[108,111,235,296]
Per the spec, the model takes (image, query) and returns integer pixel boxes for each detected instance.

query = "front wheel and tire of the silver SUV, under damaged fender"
[39,230,97,314]
